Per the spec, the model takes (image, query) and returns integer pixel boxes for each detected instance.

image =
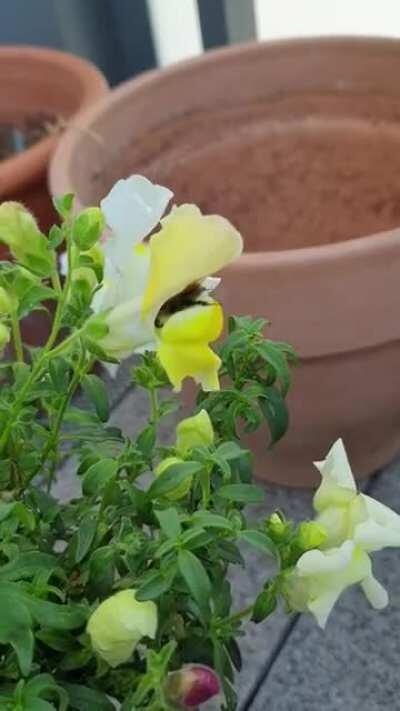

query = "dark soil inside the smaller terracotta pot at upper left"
[0,113,56,160]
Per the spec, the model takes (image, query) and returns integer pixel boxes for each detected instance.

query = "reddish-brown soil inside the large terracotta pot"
[93,92,400,251]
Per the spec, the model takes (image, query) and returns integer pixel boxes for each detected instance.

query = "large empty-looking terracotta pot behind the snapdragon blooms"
[51,38,400,485]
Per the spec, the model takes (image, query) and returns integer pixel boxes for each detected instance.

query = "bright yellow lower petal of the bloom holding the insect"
[157,303,223,390]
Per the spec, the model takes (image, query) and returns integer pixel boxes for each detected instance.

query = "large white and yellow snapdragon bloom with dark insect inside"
[93,176,242,390]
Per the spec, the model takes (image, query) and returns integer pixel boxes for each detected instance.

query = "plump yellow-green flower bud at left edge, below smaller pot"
[0,202,54,276]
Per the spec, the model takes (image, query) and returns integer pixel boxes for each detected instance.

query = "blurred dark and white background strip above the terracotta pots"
[0,0,400,85]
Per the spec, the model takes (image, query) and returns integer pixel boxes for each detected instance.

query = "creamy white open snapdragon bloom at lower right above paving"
[284,439,400,627]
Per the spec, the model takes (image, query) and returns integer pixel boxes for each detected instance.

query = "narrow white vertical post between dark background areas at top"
[147,0,203,66]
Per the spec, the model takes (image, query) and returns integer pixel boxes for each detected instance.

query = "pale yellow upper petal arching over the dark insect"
[143,205,242,313]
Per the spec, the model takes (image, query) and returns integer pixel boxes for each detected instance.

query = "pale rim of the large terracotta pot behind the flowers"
[49,35,400,271]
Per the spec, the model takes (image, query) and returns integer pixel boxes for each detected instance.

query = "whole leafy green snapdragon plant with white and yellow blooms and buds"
[0,176,400,711]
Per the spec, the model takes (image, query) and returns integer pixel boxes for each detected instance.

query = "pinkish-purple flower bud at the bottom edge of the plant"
[165,664,220,709]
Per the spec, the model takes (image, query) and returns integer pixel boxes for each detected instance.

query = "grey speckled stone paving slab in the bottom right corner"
[248,462,400,711]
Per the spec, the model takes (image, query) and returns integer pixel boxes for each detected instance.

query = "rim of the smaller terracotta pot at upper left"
[0,44,108,196]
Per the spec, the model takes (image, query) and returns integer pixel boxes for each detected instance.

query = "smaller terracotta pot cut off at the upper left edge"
[0,47,108,345]
